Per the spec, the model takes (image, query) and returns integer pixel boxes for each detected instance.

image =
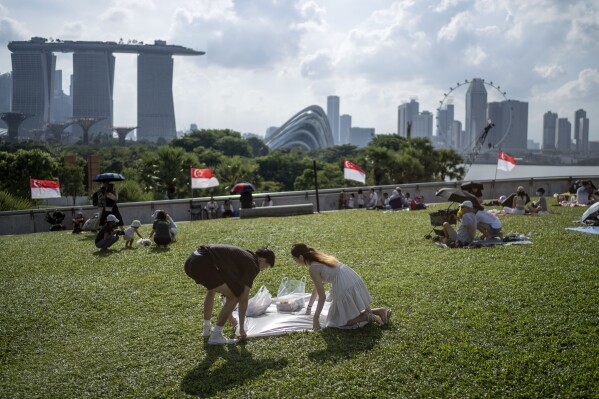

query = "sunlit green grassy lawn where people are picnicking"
[0,205,599,398]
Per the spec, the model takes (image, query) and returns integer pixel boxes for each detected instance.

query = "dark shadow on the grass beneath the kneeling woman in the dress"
[308,325,383,363]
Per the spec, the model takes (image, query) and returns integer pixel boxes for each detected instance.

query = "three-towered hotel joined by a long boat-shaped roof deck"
[8,37,205,142]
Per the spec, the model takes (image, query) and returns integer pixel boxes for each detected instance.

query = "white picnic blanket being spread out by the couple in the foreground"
[233,294,330,338]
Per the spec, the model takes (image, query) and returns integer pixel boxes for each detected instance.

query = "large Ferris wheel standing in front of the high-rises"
[437,78,513,159]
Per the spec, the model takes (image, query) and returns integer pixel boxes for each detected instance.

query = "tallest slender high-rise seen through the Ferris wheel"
[464,78,487,149]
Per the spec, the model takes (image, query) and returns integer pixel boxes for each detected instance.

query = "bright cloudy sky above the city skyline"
[0,0,599,142]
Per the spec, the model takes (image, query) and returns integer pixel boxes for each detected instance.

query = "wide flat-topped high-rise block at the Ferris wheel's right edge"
[485,100,528,150]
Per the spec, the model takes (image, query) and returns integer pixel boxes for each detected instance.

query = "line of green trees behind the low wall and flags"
[0,129,464,210]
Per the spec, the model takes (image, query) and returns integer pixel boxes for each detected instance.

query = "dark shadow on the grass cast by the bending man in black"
[181,343,288,398]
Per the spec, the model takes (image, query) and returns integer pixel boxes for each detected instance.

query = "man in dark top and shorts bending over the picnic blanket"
[184,244,275,345]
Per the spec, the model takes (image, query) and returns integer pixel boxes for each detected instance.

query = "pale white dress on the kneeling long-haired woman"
[311,262,372,327]
